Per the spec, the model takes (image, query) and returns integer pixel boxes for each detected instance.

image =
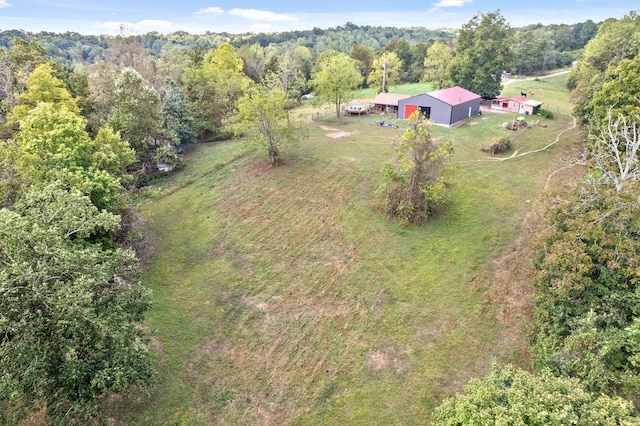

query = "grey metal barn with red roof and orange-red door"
[398,86,480,127]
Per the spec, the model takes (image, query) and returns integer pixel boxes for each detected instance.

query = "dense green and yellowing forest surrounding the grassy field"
[0,12,640,424]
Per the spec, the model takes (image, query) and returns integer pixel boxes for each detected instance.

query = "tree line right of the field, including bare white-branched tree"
[436,12,640,425]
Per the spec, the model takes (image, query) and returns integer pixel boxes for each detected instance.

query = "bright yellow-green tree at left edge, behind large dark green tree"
[0,64,134,209]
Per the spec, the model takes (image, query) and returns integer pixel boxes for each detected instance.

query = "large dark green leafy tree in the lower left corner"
[0,184,154,424]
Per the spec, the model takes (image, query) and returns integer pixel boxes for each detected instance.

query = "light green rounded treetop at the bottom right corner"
[435,365,638,426]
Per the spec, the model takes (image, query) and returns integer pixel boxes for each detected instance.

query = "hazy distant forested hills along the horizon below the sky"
[0,21,599,75]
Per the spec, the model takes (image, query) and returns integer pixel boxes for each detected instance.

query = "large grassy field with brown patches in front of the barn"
[107,76,576,425]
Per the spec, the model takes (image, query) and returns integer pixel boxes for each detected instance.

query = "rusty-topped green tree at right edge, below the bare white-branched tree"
[532,182,640,395]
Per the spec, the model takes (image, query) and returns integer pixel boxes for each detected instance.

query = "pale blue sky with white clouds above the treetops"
[0,0,640,35]
